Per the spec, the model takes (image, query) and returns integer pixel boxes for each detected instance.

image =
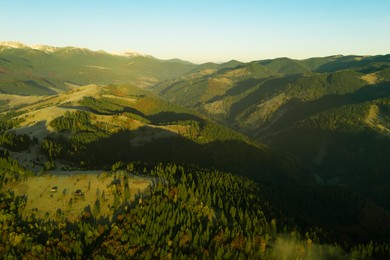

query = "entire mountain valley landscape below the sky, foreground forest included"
[0,41,390,259]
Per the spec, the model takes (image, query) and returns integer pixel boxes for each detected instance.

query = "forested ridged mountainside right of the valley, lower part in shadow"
[153,55,390,209]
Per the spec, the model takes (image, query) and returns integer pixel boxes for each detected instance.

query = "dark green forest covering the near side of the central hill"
[42,121,304,182]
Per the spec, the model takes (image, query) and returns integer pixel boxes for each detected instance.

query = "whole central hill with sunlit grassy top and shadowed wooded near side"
[0,85,312,183]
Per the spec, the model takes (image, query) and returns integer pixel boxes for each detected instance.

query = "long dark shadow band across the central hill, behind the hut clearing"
[52,126,312,183]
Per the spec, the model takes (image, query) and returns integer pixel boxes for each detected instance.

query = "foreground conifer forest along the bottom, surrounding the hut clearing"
[0,163,390,259]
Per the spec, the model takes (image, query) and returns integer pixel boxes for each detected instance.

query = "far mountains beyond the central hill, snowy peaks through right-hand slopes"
[0,42,390,193]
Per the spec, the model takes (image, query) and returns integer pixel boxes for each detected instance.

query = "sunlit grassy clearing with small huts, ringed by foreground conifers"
[3,171,151,221]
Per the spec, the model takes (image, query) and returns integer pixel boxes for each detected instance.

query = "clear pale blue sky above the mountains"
[0,0,390,63]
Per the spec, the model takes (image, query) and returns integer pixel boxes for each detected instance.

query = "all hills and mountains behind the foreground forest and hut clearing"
[0,42,390,257]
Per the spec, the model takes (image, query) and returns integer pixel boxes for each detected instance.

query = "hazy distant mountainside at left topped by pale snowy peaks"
[0,43,195,95]
